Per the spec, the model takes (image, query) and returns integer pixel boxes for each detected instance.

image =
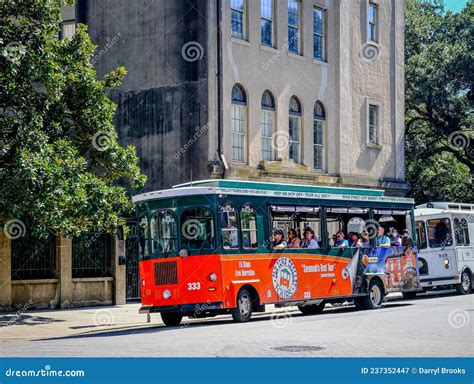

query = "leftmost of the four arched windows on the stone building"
[232,84,247,163]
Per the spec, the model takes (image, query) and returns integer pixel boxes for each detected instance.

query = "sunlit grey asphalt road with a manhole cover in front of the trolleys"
[0,293,474,357]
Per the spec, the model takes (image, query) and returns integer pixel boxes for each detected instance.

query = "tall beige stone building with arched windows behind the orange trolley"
[0,0,407,303]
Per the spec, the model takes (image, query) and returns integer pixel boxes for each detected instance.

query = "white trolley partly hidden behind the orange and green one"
[412,202,474,296]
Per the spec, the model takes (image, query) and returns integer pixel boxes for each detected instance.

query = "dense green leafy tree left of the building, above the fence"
[0,0,145,236]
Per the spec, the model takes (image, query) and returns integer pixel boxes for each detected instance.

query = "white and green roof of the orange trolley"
[133,179,414,204]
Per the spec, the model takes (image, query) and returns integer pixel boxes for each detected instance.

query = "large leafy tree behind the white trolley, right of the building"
[405,0,474,202]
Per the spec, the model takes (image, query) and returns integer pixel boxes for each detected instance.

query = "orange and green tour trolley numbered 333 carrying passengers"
[133,180,420,325]
